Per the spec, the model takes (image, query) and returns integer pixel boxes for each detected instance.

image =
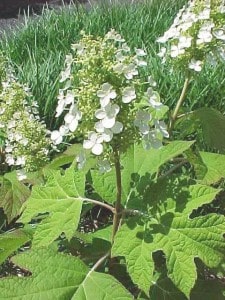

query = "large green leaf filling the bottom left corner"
[0,249,132,300]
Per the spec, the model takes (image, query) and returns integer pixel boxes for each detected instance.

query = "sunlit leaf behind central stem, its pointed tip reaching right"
[91,141,193,204]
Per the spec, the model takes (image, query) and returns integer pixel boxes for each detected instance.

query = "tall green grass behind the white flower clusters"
[0,0,225,128]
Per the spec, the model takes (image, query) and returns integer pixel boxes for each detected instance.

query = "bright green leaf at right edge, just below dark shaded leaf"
[200,152,225,185]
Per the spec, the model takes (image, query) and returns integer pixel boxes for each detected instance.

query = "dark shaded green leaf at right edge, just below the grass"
[194,107,225,152]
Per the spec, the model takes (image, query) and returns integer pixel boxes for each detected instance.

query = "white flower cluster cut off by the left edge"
[0,76,51,180]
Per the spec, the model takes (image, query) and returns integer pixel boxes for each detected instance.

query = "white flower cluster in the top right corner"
[157,0,225,72]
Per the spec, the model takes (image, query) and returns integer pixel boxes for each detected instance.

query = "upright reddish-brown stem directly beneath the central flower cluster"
[112,148,122,244]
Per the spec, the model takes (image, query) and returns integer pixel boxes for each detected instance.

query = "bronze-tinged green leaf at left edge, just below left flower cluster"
[0,172,30,223]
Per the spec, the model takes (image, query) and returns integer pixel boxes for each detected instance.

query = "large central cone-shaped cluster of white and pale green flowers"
[51,29,168,172]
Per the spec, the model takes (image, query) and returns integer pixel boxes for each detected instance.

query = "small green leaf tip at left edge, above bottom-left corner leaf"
[0,229,30,264]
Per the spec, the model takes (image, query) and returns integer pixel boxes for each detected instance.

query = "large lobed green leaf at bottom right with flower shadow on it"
[112,179,225,297]
